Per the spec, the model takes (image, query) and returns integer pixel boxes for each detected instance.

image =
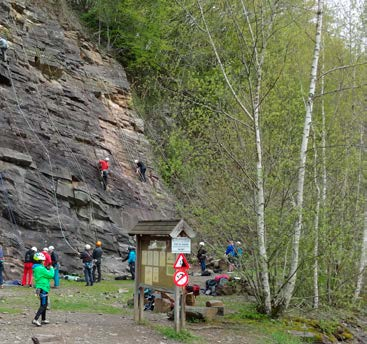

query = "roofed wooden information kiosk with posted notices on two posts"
[129,219,196,331]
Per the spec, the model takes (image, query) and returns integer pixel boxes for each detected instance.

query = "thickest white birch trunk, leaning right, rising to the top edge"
[275,0,324,311]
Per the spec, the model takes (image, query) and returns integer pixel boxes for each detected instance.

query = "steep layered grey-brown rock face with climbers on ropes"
[0,0,174,279]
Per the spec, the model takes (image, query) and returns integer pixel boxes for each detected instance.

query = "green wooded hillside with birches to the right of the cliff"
[73,0,367,315]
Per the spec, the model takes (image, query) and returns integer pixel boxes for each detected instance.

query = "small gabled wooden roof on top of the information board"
[128,219,196,238]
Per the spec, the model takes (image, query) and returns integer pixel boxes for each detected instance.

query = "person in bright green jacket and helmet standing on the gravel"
[32,252,55,326]
